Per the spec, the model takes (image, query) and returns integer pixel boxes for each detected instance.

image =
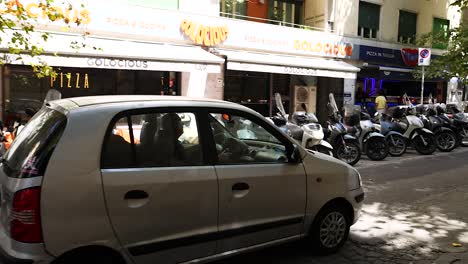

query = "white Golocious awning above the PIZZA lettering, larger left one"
[4,35,224,73]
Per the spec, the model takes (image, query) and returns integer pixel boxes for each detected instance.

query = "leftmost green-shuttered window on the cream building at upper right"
[358,1,380,38]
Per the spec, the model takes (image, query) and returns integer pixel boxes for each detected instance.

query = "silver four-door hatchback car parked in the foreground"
[0,96,364,264]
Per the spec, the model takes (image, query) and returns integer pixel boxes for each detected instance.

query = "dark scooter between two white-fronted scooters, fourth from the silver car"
[374,112,407,157]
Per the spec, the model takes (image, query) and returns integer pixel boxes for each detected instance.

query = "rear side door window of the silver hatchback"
[102,112,204,168]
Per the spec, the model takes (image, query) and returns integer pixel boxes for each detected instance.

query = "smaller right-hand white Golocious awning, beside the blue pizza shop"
[218,50,359,79]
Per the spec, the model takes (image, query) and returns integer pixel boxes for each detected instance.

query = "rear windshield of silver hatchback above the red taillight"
[3,107,67,178]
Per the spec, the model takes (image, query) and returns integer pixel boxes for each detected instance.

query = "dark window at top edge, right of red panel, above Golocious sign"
[268,0,303,26]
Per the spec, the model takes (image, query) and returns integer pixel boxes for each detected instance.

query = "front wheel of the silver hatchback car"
[308,205,351,255]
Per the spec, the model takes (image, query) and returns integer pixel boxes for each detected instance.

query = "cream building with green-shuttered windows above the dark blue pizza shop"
[322,0,462,107]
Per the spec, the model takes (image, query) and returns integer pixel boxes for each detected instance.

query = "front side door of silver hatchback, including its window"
[208,111,306,252]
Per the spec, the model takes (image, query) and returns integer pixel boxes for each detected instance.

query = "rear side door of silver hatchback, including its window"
[101,109,218,264]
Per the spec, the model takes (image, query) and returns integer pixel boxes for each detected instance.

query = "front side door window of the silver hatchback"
[209,113,288,164]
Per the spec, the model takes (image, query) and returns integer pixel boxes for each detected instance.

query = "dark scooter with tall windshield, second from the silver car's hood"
[325,93,361,165]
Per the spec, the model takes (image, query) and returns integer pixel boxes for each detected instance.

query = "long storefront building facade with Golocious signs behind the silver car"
[0,0,459,125]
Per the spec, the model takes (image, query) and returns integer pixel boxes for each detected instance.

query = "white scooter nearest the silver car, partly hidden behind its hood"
[272,93,333,156]
